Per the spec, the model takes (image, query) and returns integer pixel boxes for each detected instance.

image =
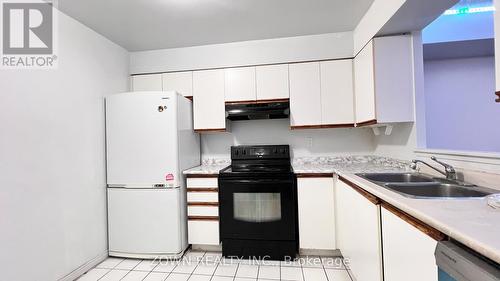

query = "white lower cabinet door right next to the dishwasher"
[382,208,438,281]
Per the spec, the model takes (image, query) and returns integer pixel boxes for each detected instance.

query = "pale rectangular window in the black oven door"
[233,192,281,222]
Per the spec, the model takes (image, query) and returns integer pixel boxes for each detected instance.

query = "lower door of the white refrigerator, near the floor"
[108,188,187,257]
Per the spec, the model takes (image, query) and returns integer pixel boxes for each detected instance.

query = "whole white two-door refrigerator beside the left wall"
[106,92,200,259]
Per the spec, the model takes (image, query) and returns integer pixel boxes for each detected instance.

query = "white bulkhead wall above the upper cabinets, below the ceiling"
[130,32,353,74]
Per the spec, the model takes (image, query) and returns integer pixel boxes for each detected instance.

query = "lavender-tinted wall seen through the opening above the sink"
[424,57,500,152]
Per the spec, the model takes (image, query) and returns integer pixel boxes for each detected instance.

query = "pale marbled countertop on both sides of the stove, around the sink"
[184,156,500,263]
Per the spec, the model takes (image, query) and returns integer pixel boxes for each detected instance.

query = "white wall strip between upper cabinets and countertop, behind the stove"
[201,119,374,158]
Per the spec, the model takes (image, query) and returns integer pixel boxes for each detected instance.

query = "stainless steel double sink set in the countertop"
[356,173,498,199]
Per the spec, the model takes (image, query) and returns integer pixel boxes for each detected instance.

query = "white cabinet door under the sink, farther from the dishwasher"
[335,180,382,281]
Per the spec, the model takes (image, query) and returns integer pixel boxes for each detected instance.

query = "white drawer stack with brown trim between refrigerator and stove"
[187,177,220,245]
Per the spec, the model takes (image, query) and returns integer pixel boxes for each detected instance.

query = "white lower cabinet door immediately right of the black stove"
[297,177,336,250]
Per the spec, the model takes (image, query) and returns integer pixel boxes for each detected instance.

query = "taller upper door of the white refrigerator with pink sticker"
[106,92,180,187]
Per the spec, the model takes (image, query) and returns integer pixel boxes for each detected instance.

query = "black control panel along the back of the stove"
[231,145,290,160]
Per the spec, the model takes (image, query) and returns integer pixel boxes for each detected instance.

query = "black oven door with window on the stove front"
[219,175,297,240]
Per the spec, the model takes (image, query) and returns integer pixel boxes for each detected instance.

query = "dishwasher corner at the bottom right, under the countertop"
[434,238,500,281]
